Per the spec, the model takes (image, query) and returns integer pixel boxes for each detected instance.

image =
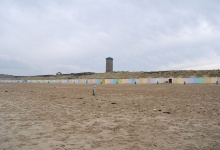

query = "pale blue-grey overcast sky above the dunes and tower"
[0,0,220,75]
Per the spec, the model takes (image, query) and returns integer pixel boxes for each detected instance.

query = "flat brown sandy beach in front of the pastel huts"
[0,84,220,150]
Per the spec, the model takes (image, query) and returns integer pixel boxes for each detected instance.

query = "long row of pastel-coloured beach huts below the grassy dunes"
[0,77,220,84]
